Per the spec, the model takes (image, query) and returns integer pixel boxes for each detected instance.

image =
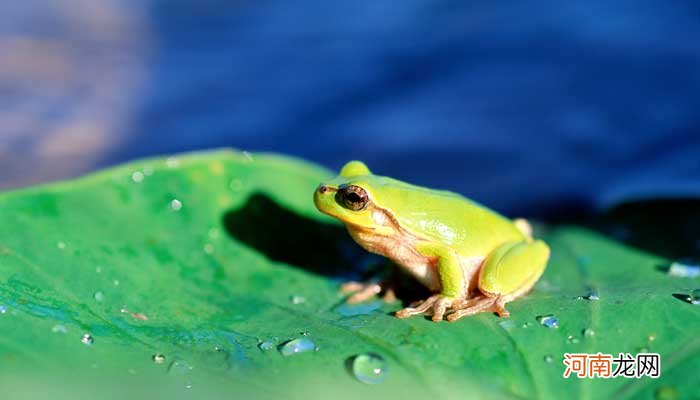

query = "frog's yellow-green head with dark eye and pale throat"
[314,161,392,235]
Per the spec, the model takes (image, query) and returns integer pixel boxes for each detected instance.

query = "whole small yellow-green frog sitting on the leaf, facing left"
[313,160,550,322]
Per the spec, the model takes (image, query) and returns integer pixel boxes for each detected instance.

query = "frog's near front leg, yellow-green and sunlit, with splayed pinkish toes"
[396,244,467,321]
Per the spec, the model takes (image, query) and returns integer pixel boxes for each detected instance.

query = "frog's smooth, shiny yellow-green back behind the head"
[366,177,524,257]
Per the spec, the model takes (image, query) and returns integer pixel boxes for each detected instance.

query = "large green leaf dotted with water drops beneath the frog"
[0,151,700,399]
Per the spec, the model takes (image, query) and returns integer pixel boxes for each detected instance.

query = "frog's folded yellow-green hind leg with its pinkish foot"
[447,240,549,321]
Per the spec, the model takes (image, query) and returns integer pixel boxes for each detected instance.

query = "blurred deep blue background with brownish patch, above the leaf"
[0,0,700,218]
